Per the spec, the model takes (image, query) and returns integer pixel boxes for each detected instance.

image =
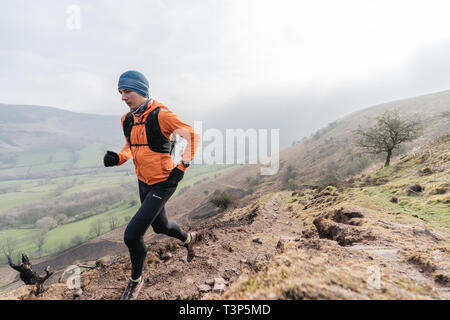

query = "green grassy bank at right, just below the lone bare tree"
[285,135,450,230]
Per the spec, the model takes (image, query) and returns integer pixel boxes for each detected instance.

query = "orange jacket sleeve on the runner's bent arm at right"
[158,109,200,171]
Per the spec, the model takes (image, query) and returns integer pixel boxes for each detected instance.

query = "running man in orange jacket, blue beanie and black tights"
[103,71,200,300]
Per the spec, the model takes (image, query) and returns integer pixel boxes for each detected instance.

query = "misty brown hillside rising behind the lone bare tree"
[143,91,450,236]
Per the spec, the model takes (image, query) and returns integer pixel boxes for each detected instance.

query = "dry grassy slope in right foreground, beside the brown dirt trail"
[222,135,450,299]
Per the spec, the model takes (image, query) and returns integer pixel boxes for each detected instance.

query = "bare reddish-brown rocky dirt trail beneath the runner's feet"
[81,193,296,300]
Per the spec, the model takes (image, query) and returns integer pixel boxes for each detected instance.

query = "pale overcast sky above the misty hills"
[0,0,450,146]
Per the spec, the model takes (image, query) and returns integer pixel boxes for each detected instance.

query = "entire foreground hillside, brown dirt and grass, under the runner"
[3,135,450,300]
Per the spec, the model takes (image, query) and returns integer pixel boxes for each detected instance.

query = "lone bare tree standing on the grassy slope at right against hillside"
[353,111,422,167]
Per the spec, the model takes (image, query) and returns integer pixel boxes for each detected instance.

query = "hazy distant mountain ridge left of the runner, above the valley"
[0,104,123,153]
